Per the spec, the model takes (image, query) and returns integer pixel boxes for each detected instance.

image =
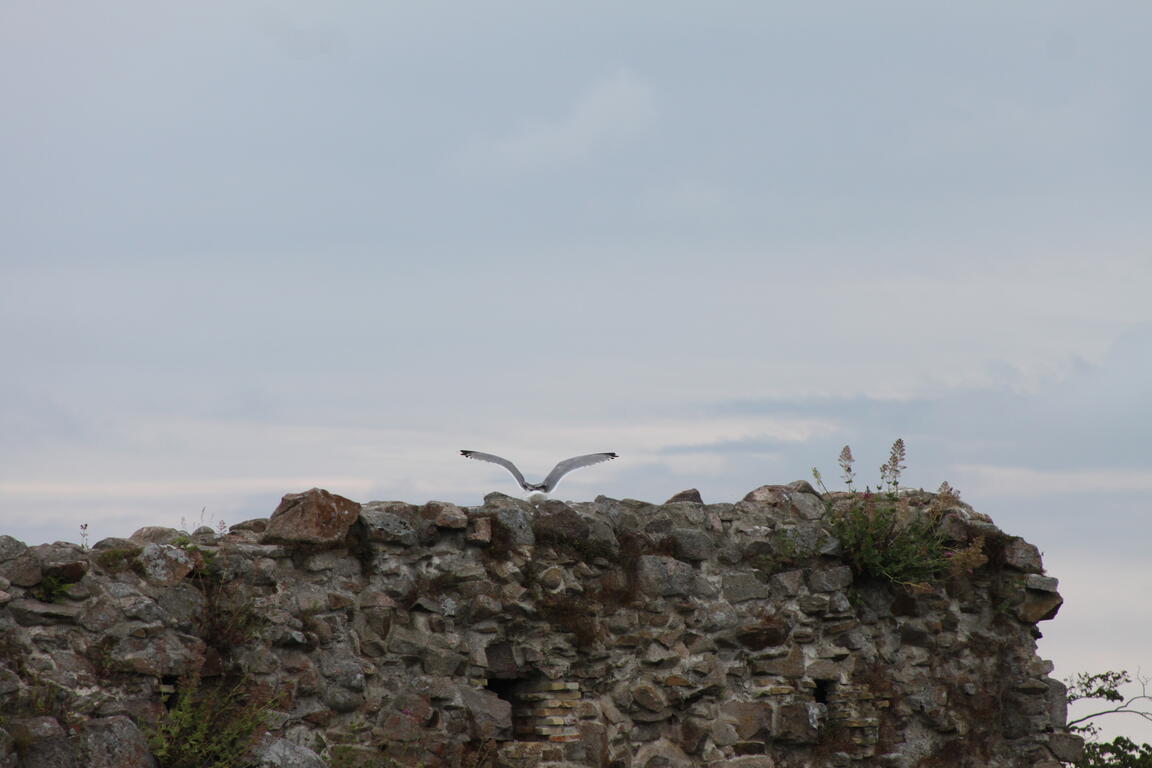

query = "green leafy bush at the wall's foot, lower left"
[147,677,271,768]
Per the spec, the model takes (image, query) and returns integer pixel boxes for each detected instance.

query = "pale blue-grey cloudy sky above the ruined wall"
[0,0,1152,740]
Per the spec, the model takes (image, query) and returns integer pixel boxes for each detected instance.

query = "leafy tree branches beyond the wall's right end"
[1064,670,1152,768]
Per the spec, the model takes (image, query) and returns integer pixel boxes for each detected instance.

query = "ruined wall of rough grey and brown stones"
[0,482,1079,768]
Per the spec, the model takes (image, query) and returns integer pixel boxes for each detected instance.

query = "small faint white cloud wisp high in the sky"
[467,69,657,170]
